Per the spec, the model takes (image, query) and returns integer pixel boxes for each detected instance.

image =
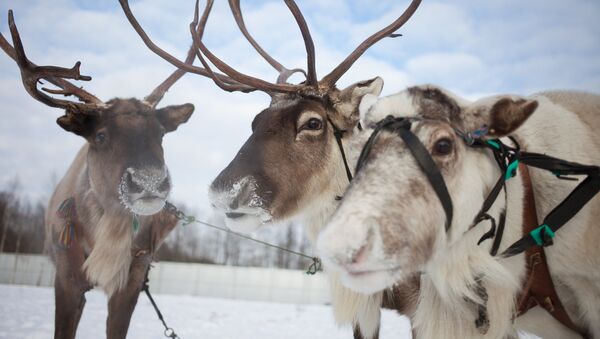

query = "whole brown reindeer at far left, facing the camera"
[0,11,194,338]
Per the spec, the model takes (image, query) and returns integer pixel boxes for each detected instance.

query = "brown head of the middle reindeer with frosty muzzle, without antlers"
[209,78,383,232]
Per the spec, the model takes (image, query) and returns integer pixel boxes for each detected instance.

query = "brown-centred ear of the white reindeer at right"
[474,97,538,137]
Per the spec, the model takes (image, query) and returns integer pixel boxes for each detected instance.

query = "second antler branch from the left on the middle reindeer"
[192,0,298,93]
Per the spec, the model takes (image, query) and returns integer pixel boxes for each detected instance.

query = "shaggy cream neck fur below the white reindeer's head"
[413,163,525,339]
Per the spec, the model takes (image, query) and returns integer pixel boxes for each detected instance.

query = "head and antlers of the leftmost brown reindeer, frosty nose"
[0,11,194,215]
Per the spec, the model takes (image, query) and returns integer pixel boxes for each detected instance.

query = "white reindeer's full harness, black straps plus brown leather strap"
[356,116,600,337]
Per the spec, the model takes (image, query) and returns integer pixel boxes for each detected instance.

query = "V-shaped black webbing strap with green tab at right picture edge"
[502,152,600,257]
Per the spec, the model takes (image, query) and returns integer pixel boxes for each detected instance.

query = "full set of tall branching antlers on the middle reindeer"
[119,0,421,97]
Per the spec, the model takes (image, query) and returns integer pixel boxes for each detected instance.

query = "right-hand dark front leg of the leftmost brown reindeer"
[106,251,152,339]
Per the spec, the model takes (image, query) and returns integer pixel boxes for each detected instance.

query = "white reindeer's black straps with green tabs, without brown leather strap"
[354,116,600,257]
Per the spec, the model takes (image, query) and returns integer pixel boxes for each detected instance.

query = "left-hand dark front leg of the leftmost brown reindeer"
[54,249,91,339]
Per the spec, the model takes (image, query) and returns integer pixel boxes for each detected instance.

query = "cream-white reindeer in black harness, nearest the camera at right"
[318,85,600,338]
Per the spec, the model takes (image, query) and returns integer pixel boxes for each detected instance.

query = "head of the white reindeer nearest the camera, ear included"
[318,86,538,293]
